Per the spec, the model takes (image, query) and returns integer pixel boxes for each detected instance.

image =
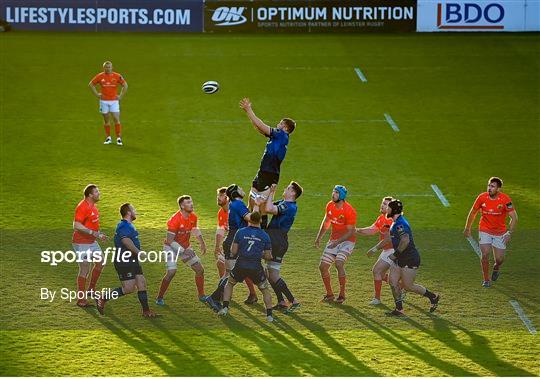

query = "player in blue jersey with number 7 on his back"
[218,211,274,322]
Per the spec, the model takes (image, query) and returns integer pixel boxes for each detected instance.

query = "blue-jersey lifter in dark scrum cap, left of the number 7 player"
[205,184,258,311]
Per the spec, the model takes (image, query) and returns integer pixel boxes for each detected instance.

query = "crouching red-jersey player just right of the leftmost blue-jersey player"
[156,195,206,305]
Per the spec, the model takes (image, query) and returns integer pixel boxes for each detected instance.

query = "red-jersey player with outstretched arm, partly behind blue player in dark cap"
[356,196,395,305]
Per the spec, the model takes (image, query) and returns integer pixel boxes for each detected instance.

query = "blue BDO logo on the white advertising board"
[437,2,504,29]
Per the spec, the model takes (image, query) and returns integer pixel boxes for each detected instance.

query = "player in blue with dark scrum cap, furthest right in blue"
[386,199,440,316]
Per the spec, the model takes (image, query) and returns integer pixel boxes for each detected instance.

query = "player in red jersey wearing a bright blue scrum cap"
[315,185,356,304]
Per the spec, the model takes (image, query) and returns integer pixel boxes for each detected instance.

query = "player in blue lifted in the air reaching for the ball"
[240,98,296,229]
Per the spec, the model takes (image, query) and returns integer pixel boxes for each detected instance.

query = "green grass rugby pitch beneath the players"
[0,32,540,376]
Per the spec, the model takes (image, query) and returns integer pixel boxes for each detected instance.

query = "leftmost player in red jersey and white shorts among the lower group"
[72,184,107,308]
